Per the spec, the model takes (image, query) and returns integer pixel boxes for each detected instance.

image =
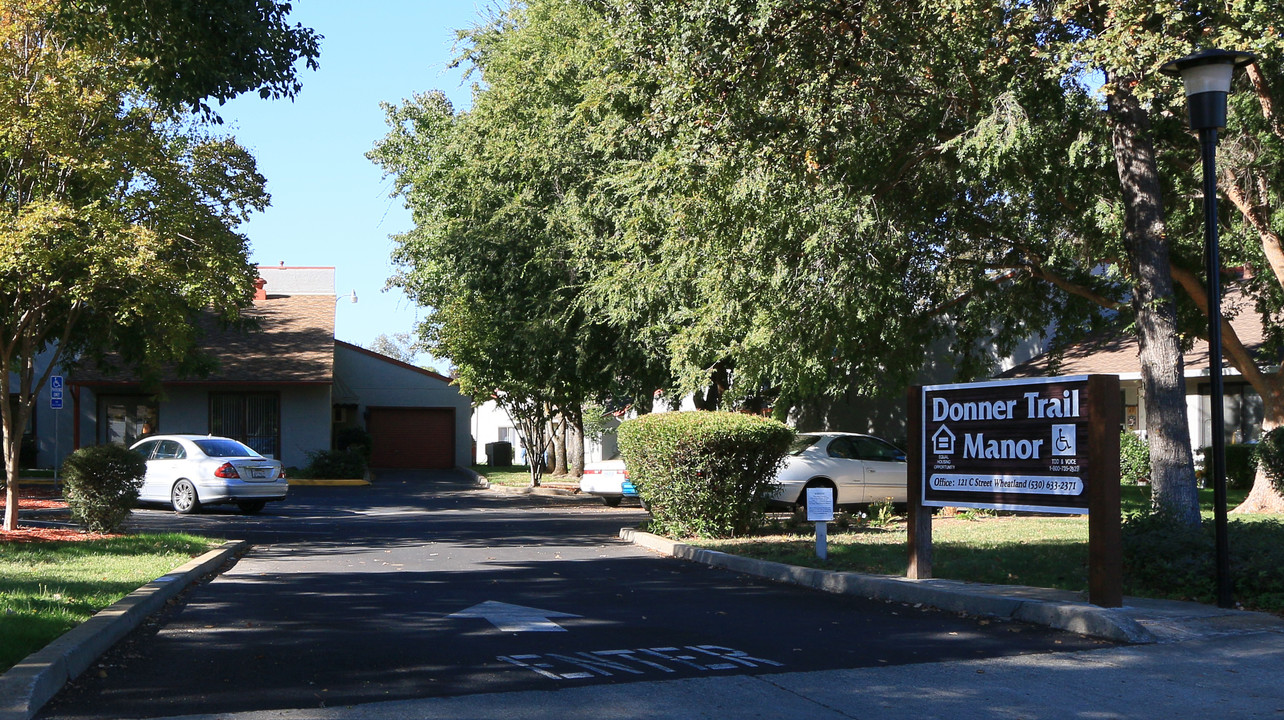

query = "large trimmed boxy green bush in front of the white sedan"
[618,412,794,538]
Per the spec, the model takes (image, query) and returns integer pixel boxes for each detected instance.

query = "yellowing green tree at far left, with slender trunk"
[0,0,295,530]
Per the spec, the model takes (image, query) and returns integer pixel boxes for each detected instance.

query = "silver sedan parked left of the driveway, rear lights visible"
[130,435,289,513]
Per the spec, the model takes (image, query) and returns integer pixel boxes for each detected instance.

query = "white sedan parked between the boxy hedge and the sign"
[772,433,908,507]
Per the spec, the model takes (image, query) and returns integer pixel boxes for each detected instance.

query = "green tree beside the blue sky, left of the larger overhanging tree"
[370,1,654,484]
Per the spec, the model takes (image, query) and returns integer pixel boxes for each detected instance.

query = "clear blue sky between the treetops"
[218,0,490,361]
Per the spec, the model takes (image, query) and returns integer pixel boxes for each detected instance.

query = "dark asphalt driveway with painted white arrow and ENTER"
[41,472,1103,719]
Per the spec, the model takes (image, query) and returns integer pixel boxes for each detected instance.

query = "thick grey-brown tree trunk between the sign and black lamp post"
[1107,78,1199,526]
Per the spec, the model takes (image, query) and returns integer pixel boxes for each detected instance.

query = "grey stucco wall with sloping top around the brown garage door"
[334,344,473,466]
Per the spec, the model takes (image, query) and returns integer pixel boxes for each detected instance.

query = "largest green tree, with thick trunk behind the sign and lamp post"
[577,0,1279,522]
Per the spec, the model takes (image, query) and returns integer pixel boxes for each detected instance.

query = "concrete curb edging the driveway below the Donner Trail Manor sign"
[620,527,1158,644]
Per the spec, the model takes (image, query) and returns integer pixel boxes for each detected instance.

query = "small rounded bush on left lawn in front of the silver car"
[63,445,148,533]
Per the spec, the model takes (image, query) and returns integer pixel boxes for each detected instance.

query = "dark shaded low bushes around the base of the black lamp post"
[1124,513,1284,612]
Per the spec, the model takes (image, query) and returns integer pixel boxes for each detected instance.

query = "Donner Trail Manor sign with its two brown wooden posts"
[908,375,1122,606]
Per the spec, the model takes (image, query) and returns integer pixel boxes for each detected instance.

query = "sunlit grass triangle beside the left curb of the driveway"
[0,534,221,673]
